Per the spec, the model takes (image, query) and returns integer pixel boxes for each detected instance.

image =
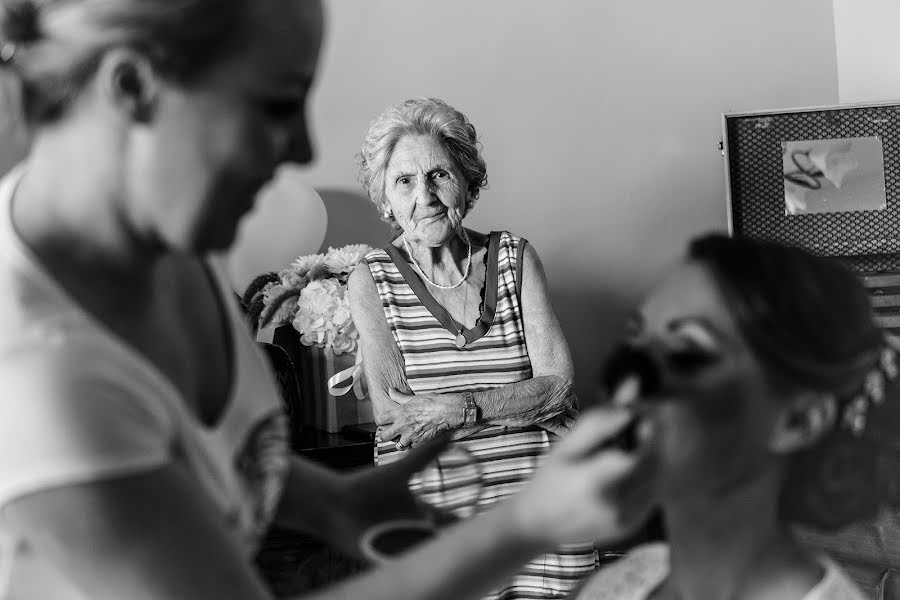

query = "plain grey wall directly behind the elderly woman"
[308,0,849,399]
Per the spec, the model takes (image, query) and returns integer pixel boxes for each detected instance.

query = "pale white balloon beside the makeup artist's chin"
[225,166,328,294]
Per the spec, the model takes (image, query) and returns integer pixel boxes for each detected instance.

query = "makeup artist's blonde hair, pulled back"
[0,0,248,123]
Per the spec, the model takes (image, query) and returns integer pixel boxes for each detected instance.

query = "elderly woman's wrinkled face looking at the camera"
[384,135,468,247]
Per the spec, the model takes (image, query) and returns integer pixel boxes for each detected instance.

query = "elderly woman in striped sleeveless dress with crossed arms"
[349,99,596,598]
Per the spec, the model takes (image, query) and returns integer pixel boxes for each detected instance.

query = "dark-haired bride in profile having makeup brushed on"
[578,235,888,600]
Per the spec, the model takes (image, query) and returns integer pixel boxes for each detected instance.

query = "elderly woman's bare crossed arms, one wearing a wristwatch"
[349,246,577,446]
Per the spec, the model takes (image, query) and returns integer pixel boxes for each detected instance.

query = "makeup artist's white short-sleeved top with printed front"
[0,167,288,600]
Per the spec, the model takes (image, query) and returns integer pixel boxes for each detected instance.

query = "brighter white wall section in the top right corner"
[833,0,900,102]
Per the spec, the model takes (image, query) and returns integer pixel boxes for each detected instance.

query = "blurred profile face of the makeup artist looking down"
[135,0,322,252]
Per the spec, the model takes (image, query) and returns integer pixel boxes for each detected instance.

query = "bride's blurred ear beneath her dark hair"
[769,392,837,454]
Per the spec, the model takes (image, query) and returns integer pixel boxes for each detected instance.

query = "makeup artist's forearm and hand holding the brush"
[298,409,655,600]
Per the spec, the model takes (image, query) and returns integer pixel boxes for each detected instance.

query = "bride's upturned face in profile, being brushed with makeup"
[629,263,781,504]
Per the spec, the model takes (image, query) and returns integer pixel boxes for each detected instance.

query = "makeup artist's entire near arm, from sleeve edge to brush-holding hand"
[2,404,653,600]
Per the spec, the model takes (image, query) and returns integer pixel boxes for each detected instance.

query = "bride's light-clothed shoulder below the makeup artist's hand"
[574,543,669,600]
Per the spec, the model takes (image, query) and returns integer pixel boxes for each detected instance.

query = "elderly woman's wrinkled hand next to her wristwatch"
[378,388,465,449]
